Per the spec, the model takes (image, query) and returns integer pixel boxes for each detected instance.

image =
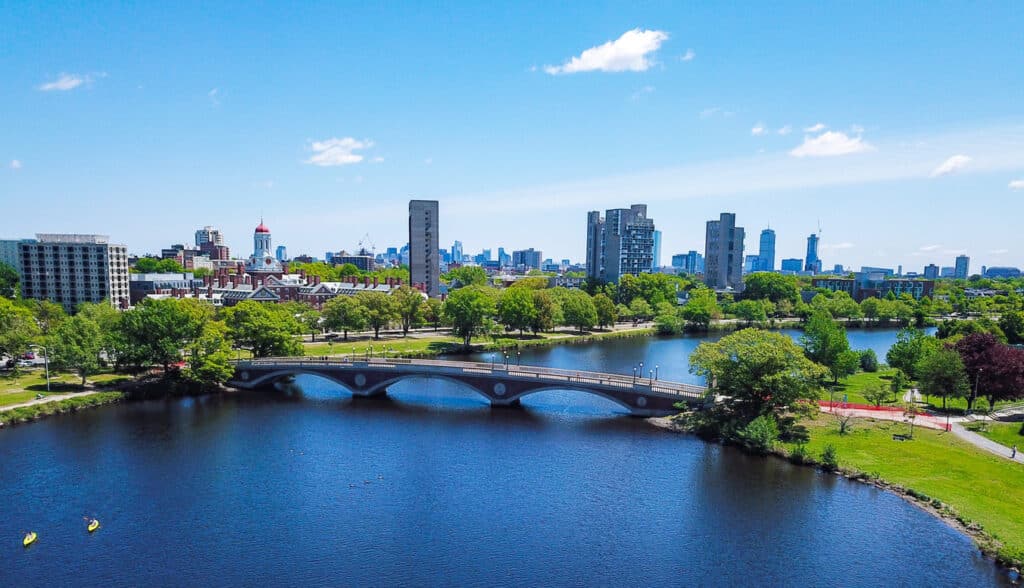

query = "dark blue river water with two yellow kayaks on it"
[0,329,1006,587]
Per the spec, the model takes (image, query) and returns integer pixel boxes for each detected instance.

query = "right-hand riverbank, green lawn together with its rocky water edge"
[648,415,1024,573]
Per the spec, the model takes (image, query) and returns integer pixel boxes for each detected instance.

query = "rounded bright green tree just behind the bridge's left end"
[222,300,303,358]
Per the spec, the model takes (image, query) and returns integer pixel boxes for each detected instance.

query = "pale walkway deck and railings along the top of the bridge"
[238,358,708,400]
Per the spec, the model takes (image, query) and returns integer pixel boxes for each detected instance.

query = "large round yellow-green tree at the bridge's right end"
[690,329,826,424]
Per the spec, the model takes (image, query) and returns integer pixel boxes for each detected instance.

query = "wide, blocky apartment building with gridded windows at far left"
[5,234,130,310]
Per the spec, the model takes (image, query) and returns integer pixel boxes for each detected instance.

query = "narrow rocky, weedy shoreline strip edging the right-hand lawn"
[644,416,1024,584]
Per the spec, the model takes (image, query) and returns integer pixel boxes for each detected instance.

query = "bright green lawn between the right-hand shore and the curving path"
[794,416,1024,558]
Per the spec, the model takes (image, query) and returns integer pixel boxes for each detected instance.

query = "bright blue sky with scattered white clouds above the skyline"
[0,0,1024,270]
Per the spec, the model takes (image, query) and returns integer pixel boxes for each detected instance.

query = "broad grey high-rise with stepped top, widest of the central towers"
[587,204,654,282]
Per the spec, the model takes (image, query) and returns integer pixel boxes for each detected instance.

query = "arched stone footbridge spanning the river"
[228,358,708,417]
